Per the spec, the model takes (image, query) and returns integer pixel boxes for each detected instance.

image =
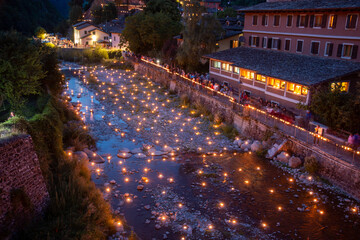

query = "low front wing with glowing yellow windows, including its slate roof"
[204,47,360,114]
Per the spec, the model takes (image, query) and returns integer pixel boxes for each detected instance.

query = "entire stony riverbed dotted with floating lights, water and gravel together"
[63,65,360,239]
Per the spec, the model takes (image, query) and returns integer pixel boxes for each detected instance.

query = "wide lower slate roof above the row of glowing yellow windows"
[204,47,360,86]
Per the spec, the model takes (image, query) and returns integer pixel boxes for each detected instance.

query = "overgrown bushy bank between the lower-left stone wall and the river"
[7,99,114,239]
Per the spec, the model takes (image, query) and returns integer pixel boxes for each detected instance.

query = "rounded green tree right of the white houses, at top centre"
[122,0,181,56]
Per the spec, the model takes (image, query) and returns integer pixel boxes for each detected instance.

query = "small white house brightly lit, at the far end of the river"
[73,22,110,47]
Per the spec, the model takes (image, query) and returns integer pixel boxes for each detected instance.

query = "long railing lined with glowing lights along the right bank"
[141,59,360,167]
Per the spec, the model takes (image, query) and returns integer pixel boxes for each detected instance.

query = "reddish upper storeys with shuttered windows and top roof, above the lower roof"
[238,0,360,62]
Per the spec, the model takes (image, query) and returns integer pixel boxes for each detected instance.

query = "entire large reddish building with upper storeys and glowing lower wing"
[204,0,360,114]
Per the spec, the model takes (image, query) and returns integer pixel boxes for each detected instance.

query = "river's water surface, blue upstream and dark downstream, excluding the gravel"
[64,67,360,239]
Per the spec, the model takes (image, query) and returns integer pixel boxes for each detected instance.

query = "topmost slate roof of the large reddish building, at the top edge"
[238,0,360,12]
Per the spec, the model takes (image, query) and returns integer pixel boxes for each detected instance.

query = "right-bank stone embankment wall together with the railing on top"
[135,60,360,199]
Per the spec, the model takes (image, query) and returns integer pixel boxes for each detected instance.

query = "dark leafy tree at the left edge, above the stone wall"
[0,32,45,112]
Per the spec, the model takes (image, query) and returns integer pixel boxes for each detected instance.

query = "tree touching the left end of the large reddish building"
[176,0,223,71]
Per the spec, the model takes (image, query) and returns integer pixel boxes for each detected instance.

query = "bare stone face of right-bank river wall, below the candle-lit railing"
[134,63,360,199]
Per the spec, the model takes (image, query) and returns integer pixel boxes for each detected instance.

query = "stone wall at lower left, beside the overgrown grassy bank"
[0,135,49,234]
